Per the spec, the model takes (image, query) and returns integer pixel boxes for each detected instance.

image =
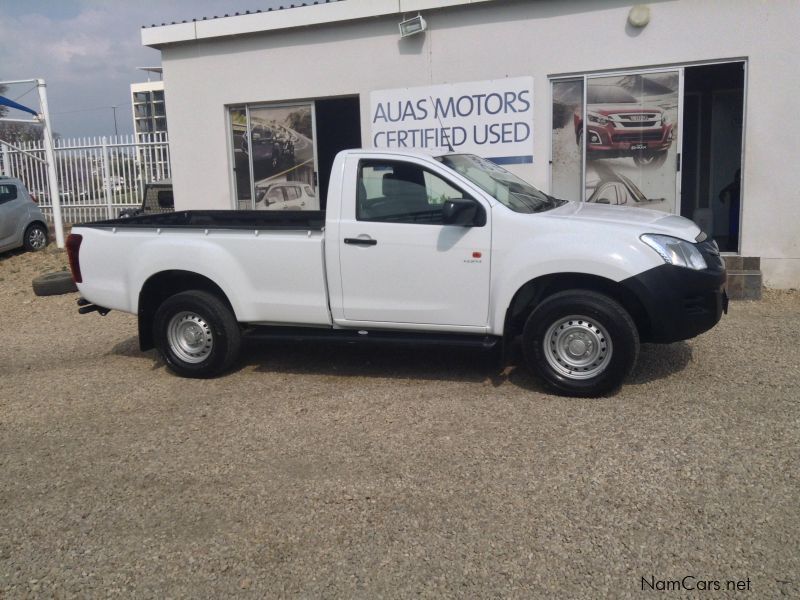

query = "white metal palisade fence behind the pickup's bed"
[0,133,171,224]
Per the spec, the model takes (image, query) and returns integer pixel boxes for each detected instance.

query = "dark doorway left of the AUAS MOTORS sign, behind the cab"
[314,96,361,210]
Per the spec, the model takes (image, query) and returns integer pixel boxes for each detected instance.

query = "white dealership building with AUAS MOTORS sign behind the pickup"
[142,0,800,287]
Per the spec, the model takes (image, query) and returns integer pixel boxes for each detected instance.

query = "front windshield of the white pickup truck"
[436,154,566,213]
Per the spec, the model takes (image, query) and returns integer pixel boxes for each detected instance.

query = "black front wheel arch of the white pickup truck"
[503,273,651,341]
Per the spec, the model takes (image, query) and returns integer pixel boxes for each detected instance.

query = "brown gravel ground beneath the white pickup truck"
[0,249,800,598]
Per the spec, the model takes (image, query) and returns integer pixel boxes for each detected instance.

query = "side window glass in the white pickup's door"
[356,160,470,225]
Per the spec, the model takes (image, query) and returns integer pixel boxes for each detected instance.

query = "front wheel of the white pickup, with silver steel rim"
[522,290,639,397]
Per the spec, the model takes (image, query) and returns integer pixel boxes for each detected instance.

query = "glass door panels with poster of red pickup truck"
[553,72,679,212]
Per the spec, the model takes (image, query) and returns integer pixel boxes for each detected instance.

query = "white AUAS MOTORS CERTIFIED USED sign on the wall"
[370,77,533,164]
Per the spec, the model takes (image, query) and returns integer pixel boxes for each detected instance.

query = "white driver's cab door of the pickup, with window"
[339,159,491,327]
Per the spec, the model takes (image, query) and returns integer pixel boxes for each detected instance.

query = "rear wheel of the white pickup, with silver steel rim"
[153,290,241,378]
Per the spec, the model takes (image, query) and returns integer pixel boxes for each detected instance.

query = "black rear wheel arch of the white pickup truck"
[137,270,236,350]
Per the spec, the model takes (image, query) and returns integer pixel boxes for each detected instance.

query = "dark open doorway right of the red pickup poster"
[681,62,745,252]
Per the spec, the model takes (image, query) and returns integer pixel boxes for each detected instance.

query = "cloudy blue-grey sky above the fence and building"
[0,0,296,137]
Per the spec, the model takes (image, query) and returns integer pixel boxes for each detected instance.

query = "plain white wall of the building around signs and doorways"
[162,0,800,287]
